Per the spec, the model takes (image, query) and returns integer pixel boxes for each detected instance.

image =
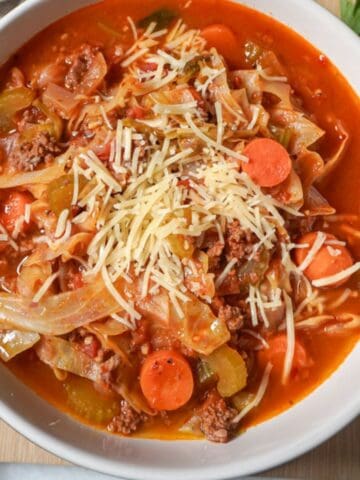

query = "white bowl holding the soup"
[0,0,360,480]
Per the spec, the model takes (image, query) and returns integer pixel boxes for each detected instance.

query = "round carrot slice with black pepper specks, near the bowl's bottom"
[140,350,194,410]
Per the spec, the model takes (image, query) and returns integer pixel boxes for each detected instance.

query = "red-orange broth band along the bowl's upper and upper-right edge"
[5,0,360,208]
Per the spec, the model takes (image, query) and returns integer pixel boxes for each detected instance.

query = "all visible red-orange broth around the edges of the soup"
[0,0,360,439]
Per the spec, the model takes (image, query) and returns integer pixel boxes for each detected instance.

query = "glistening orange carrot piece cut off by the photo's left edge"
[0,191,33,234]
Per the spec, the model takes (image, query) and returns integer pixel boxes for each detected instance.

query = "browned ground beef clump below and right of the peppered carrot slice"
[199,390,238,443]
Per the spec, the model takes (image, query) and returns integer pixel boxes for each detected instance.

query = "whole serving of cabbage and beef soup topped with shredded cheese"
[0,0,360,442]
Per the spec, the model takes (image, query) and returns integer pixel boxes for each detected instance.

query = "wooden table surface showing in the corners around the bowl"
[0,0,360,480]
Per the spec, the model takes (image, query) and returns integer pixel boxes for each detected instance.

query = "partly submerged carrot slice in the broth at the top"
[201,23,240,64]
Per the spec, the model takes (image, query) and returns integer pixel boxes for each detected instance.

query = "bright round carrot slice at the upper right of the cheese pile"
[242,138,291,187]
